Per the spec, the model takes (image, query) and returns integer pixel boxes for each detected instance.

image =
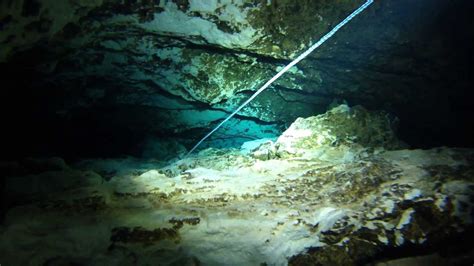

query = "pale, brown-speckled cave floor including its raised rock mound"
[0,105,474,265]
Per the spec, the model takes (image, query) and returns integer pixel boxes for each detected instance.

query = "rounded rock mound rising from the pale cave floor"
[251,105,406,159]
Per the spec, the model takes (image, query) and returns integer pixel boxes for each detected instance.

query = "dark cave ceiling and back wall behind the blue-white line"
[0,0,474,157]
